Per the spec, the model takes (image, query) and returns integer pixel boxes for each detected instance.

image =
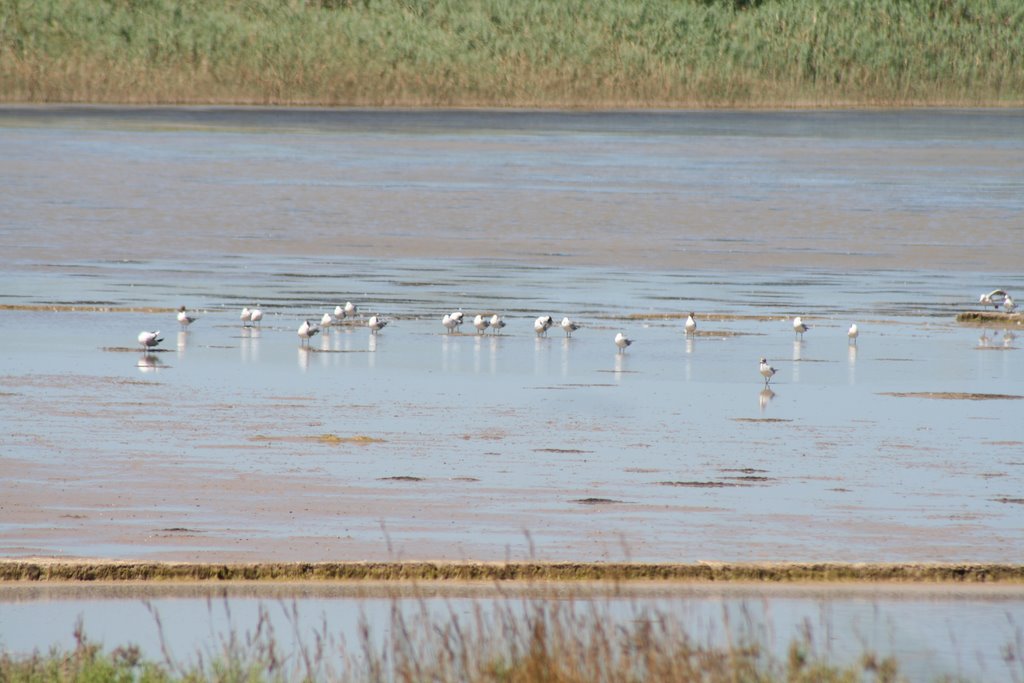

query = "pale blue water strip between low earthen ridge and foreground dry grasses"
[0,585,1024,681]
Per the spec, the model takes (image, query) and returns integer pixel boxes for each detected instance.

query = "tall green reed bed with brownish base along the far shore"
[0,0,1024,108]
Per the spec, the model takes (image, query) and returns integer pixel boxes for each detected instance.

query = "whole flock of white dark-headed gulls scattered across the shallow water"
[130,290,1017,387]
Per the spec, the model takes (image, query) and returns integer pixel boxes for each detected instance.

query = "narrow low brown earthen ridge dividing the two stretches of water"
[0,560,1024,584]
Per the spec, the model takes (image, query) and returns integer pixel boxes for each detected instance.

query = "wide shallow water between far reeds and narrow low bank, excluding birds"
[0,108,1024,671]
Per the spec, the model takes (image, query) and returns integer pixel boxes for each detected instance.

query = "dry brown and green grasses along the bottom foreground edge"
[0,600,950,683]
